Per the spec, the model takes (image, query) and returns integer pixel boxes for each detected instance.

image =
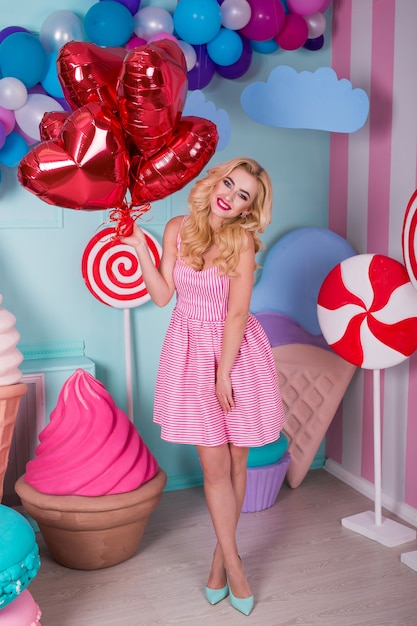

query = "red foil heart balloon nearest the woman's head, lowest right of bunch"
[129,116,219,205]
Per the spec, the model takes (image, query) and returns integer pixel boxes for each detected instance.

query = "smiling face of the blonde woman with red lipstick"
[210,167,258,226]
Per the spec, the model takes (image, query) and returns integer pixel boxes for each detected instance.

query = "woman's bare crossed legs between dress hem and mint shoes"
[197,444,251,598]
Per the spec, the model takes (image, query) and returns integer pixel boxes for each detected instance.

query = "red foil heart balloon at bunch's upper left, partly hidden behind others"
[57,41,126,113]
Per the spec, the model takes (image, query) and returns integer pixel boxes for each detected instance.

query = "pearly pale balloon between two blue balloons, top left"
[39,11,84,52]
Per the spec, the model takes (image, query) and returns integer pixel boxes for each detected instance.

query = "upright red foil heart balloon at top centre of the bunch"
[117,39,187,158]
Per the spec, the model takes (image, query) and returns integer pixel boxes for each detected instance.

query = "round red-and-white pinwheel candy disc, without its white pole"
[317,254,417,370]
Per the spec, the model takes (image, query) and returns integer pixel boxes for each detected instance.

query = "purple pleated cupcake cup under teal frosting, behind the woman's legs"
[242,452,291,513]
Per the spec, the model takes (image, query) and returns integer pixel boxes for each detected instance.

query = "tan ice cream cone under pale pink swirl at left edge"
[0,383,27,502]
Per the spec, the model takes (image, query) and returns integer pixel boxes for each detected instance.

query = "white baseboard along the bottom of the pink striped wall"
[324,459,417,527]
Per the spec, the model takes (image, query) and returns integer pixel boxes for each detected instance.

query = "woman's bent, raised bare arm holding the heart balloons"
[121,216,182,307]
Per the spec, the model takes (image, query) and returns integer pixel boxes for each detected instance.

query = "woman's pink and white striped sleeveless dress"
[154,238,284,447]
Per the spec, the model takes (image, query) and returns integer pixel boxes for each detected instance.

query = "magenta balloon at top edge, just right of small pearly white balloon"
[238,0,285,41]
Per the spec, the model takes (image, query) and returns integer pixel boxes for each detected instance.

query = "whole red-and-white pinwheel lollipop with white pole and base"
[317,254,417,547]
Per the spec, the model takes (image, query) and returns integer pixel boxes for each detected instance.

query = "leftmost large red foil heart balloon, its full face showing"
[18,102,129,210]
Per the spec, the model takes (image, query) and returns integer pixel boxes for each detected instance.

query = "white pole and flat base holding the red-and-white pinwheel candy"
[342,370,417,544]
